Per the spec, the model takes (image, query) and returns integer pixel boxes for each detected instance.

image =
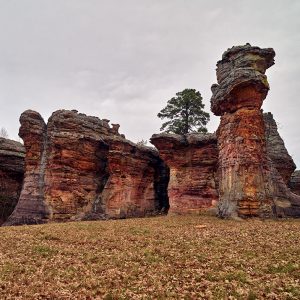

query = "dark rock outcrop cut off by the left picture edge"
[0,138,25,225]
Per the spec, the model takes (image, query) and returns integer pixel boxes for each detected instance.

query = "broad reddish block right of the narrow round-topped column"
[45,110,109,220]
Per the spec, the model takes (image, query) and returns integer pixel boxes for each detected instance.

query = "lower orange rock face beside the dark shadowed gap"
[102,136,168,218]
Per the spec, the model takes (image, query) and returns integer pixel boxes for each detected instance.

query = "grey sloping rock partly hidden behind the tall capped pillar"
[263,112,296,184]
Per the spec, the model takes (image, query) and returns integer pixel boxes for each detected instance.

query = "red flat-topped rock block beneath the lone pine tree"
[151,133,218,214]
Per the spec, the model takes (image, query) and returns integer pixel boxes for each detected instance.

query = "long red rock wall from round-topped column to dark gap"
[6,110,167,225]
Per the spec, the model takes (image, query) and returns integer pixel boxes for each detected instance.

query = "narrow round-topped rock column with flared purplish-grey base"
[4,110,49,225]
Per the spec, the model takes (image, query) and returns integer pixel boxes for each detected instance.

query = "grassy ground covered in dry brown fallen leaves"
[0,216,300,299]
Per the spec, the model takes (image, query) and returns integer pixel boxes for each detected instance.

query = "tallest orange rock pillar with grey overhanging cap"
[211,44,300,217]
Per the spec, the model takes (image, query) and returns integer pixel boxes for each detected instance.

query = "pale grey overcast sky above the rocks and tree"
[0,0,300,167]
